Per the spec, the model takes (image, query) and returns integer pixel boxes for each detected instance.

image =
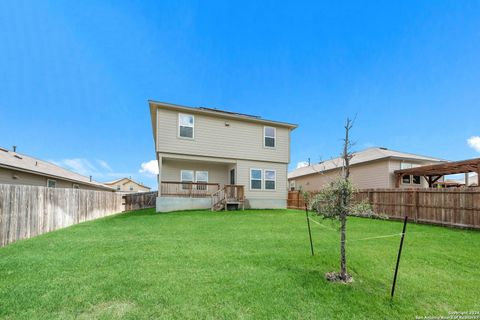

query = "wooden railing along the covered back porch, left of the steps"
[160,181,220,198]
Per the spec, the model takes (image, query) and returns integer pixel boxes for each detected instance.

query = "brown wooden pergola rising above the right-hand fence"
[394,158,480,188]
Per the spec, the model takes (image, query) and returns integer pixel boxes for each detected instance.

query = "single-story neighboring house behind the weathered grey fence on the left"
[0,148,115,191]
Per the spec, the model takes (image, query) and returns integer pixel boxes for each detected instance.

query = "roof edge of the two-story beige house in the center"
[148,100,298,143]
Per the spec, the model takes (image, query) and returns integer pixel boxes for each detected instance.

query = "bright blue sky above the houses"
[0,0,480,187]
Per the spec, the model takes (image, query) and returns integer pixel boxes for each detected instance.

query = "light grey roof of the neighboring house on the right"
[288,147,446,179]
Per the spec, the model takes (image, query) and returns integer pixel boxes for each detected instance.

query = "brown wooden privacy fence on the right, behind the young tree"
[288,188,480,229]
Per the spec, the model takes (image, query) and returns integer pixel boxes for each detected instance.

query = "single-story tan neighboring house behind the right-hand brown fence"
[288,148,445,191]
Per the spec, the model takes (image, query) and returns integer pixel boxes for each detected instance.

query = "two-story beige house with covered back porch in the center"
[149,101,297,211]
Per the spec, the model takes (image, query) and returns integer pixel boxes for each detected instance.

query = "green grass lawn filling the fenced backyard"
[0,210,480,319]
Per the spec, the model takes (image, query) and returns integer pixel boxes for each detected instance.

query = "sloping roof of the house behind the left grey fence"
[0,148,114,191]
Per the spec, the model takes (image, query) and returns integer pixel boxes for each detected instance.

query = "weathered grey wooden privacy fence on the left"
[0,184,123,247]
